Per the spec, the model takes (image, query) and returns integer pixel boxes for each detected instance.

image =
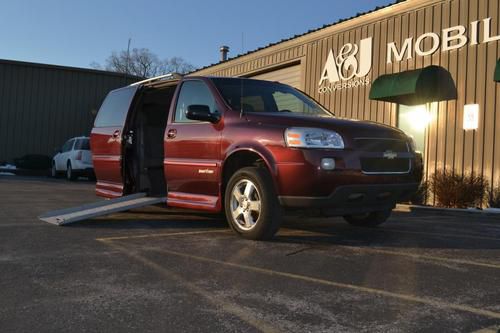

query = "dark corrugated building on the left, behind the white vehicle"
[0,61,137,162]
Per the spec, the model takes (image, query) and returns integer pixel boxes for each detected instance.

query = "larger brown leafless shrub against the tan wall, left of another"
[430,171,488,208]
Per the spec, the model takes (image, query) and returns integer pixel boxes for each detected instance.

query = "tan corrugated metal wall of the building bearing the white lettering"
[194,0,500,195]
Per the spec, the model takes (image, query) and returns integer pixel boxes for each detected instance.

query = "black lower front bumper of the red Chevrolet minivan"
[278,183,419,216]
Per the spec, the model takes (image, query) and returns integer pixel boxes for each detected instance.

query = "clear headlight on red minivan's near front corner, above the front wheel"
[285,127,344,149]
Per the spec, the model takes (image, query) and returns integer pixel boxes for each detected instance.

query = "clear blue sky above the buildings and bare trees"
[0,0,394,68]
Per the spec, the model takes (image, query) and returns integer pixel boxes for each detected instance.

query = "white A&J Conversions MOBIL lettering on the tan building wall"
[318,17,500,94]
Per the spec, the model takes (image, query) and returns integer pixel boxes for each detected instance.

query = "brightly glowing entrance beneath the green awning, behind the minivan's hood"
[398,104,430,153]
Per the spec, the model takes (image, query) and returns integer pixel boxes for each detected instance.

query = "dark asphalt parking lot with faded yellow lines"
[0,176,500,332]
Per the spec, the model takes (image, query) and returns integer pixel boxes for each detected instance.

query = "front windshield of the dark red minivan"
[212,78,332,117]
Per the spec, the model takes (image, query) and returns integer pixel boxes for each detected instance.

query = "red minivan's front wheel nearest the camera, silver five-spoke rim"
[224,167,282,240]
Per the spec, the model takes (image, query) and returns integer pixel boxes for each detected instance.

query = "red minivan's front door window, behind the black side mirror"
[175,81,216,123]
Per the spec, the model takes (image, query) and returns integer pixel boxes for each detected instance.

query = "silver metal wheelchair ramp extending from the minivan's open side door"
[38,193,167,225]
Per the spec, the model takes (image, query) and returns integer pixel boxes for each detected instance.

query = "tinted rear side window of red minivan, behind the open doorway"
[94,86,137,127]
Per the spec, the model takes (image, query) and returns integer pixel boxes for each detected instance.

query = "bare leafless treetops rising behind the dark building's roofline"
[90,48,194,77]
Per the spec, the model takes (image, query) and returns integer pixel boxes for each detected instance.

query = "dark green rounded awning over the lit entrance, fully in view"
[370,66,457,105]
